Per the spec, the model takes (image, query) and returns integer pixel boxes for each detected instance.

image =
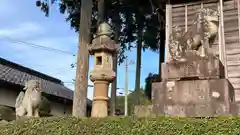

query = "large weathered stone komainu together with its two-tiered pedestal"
[152,8,236,117]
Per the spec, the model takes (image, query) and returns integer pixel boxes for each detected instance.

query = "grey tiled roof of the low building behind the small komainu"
[0,58,91,104]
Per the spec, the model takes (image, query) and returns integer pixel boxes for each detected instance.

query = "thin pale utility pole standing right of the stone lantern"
[124,58,134,116]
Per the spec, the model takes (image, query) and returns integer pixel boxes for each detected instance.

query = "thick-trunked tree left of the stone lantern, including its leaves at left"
[36,0,93,117]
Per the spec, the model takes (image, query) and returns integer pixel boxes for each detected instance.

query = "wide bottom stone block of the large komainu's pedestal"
[152,79,236,117]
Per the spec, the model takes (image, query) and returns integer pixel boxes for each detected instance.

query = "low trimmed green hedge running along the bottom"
[0,117,240,135]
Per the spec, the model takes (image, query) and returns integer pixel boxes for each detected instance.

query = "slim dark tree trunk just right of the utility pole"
[135,30,142,105]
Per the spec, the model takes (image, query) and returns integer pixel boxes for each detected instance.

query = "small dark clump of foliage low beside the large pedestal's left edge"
[144,73,161,100]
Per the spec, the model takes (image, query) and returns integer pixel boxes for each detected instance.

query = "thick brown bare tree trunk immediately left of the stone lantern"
[72,0,92,117]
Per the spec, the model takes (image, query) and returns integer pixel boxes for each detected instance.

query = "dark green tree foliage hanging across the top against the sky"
[36,0,164,63]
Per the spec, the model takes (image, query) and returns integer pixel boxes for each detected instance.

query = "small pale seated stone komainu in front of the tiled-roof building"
[15,80,42,119]
